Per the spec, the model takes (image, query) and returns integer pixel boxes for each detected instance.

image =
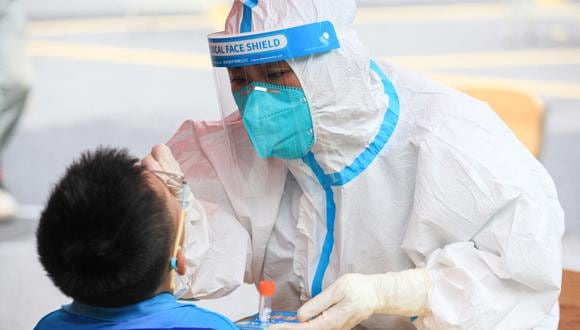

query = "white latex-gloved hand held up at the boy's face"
[141,144,193,207]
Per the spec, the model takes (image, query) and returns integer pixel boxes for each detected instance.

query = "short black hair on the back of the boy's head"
[36,148,174,307]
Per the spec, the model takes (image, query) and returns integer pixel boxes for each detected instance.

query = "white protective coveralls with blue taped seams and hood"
[168,0,564,329]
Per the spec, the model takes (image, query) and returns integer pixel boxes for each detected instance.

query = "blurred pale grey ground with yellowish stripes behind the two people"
[0,0,580,329]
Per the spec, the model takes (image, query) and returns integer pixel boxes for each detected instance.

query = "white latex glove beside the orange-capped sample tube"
[268,268,431,330]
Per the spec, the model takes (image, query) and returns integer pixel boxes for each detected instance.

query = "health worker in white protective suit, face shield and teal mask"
[143,0,564,329]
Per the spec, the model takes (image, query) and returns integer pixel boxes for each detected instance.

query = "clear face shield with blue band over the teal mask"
[208,21,339,193]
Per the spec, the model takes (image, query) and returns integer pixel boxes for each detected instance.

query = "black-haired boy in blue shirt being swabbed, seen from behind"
[36,148,237,329]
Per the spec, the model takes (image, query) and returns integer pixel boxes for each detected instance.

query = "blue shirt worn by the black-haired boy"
[35,293,238,330]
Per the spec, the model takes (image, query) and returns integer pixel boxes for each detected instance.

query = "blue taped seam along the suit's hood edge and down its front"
[302,61,400,297]
